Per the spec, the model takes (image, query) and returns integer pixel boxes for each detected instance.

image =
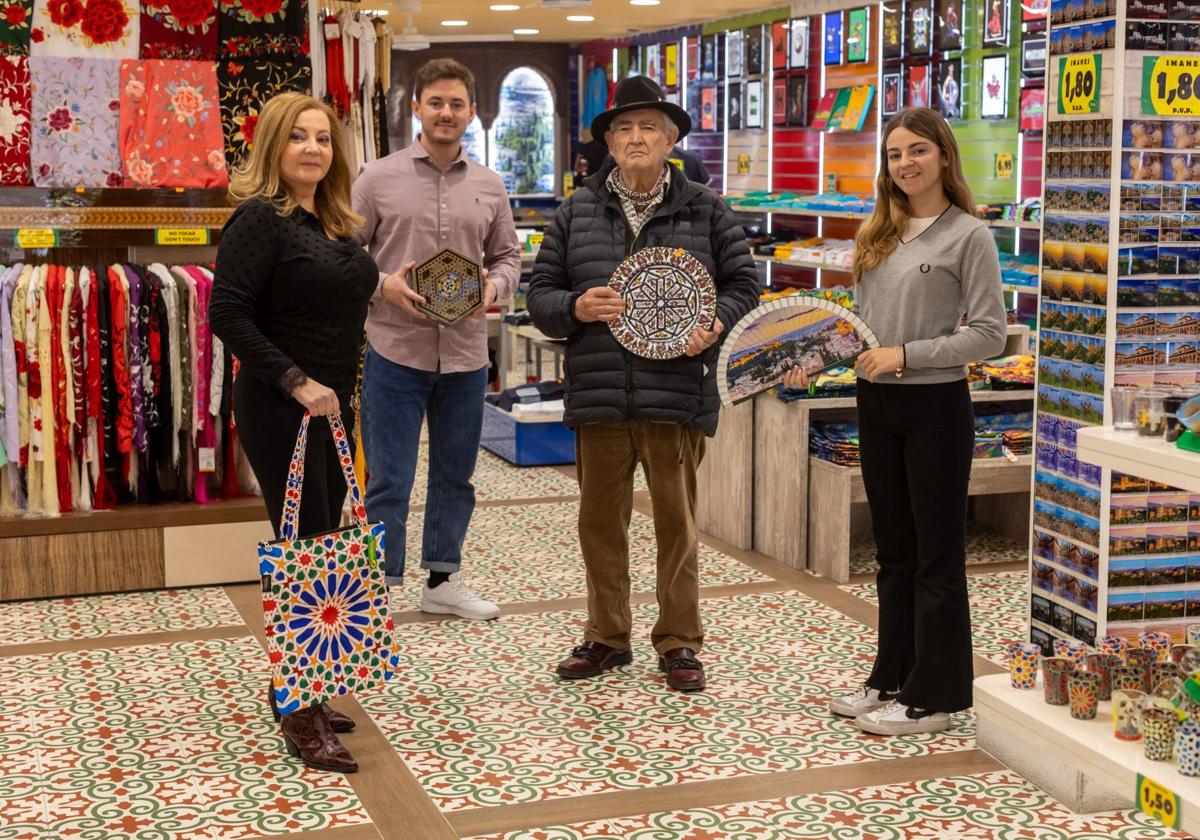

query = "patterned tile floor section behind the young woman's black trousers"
[841,571,1030,665]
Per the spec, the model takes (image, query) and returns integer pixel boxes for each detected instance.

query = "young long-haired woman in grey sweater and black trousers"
[785,108,1007,734]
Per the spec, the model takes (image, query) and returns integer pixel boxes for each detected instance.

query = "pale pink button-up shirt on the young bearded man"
[354,137,521,373]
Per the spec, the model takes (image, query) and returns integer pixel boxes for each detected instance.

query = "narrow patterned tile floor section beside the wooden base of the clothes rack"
[0,587,244,647]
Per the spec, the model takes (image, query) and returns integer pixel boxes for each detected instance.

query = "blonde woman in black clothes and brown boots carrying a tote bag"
[209,92,379,773]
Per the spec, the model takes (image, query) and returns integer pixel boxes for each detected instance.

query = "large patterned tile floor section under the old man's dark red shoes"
[360,592,974,811]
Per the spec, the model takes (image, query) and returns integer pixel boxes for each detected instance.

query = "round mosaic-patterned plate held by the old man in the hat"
[608,247,716,359]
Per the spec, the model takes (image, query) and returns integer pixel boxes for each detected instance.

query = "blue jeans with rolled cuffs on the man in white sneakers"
[362,346,487,583]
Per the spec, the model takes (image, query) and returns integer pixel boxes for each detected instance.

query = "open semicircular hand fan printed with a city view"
[716,294,880,406]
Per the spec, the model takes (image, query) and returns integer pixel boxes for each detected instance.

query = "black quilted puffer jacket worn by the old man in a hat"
[527,162,760,436]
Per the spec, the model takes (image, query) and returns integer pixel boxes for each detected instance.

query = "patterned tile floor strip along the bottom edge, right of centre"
[470,772,1187,840]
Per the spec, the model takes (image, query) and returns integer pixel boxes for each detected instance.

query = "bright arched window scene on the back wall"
[487,67,554,194]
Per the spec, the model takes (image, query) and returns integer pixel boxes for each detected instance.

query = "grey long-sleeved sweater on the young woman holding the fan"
[854,205,1008,385]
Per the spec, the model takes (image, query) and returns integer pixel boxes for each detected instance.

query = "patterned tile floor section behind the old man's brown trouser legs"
[392,502,770,610]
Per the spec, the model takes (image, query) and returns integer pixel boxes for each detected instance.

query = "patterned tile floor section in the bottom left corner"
[0,637,370,840]
